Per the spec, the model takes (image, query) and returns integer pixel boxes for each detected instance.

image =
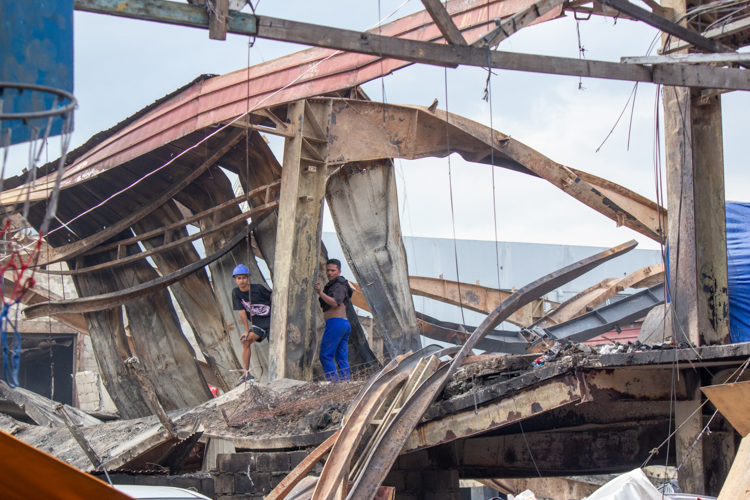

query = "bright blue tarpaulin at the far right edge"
[727,202,750,343]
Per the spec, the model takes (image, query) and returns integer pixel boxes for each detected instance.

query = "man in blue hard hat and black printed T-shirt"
[232,264,271,385]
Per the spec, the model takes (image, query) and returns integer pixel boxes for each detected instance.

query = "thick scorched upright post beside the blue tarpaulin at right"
[662,0,729,345]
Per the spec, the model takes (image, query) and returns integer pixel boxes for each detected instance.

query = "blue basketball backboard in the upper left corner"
[0,0,73,144]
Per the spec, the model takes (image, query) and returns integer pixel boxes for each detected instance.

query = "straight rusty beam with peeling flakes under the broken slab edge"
[402,374,585,453]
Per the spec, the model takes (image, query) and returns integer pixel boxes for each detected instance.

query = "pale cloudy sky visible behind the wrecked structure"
[6,0,750,254]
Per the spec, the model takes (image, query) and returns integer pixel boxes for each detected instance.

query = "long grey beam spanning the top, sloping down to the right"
[75,0,750,90]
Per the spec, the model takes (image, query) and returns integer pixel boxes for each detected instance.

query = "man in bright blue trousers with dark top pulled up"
[315,259,353,381]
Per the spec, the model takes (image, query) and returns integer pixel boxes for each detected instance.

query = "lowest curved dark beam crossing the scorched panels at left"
[23,212,276,319]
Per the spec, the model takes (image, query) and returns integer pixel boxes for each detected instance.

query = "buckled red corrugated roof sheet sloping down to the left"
[0,0,562,204]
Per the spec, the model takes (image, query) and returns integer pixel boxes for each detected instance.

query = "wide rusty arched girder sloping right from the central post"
[329,99,667,241]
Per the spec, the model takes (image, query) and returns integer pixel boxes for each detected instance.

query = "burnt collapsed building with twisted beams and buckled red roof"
[0,0,750,500]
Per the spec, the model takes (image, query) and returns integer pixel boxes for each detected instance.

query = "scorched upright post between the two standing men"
[270,99,332,380]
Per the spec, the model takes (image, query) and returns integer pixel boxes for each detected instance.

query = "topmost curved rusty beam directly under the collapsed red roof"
[29,130,244,266]
